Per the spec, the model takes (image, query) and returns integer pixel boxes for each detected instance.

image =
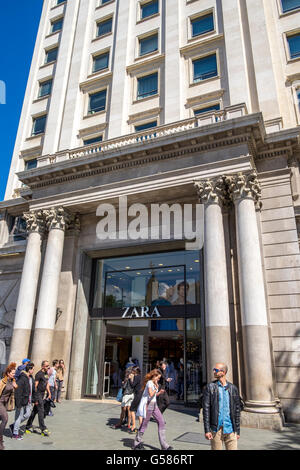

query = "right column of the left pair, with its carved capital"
[31,207,70,364]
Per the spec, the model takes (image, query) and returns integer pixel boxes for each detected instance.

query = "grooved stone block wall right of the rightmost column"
[260,169,300,421]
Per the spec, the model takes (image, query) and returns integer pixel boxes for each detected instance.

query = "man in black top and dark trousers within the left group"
[26,361,51,437]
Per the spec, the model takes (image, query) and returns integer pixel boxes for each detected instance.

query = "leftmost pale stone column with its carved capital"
[10,211,45,363]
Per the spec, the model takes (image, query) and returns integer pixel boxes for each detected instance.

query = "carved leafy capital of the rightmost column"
[226,171,262,209]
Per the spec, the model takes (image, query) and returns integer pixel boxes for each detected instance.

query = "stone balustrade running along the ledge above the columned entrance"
[38,103,247,168]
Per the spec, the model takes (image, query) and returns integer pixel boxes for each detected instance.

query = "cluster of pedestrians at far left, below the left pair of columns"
[0,358,65,450]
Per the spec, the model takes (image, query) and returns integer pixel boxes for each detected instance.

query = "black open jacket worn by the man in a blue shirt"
[202,380,241,435]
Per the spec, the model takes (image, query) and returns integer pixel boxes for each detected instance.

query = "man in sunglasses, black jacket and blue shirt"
[203,363,241,450]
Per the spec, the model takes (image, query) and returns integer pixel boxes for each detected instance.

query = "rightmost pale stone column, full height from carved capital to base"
[226,171,278,413]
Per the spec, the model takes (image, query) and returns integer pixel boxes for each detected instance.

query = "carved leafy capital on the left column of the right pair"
[194,176,228,206]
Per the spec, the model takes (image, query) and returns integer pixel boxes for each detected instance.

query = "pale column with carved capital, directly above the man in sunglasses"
[195,177,232,381]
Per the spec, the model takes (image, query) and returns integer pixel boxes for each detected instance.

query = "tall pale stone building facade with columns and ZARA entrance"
[0,0,300,429]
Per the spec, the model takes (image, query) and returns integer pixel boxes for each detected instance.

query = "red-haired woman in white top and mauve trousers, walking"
[133,369,173,450]
